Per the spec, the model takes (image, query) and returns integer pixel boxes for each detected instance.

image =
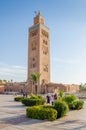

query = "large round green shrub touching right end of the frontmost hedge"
[54,100,69,118]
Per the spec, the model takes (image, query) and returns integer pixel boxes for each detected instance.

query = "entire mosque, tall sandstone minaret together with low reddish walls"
[0,12,79,94]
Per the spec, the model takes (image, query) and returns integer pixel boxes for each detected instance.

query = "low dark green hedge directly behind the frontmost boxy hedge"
[22,98,45,106]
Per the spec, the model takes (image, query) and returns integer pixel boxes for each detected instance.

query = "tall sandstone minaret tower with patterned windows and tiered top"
[28,12,50,93]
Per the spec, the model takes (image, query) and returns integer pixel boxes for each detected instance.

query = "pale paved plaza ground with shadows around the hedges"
[0,95,86,130]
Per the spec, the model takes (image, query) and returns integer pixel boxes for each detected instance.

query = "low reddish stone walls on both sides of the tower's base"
[0,82,79,94]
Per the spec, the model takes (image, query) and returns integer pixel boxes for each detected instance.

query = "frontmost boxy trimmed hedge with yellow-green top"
[26,106,57,121]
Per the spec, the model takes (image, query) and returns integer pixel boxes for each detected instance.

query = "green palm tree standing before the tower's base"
[31,72,40,95]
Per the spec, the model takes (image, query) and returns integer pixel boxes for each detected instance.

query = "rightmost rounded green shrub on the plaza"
[70,100,84,110]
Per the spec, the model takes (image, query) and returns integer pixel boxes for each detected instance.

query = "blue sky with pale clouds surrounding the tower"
[0,0,86,84]
